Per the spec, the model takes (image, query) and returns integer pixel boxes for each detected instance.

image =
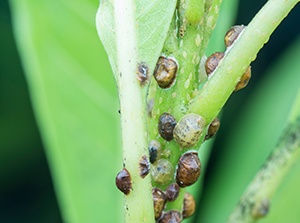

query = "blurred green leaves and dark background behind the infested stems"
[0,0,300,223]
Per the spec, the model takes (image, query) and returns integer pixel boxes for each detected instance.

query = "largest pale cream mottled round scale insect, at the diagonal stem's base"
[173,113,205,148]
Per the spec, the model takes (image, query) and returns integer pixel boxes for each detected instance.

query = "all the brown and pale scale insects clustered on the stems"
[116,25,251,223]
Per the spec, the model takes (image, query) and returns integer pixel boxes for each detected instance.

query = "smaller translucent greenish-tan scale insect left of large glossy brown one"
[151,159,174,184]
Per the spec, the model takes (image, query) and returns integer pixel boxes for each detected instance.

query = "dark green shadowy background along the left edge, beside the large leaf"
[0,1,61,223]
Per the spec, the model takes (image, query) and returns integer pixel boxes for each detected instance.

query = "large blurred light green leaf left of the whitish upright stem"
[11,0,122,223]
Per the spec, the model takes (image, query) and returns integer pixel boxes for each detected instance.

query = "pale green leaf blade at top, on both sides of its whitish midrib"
[96,0,177,81]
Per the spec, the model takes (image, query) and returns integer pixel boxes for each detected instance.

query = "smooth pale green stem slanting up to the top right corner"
[189,0,299,123]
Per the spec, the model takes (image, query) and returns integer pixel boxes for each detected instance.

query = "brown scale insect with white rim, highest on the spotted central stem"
[153,56,178,88]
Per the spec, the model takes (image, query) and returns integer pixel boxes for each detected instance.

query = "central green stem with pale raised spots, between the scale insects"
[149,0,221,214]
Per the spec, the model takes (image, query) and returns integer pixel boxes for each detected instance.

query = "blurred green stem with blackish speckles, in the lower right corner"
[228,116,300,223]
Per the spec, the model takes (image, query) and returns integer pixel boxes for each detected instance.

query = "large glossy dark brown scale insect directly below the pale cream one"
[176,152,201,187]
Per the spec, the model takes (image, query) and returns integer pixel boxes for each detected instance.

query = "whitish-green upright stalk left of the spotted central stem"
[114,0,154,223]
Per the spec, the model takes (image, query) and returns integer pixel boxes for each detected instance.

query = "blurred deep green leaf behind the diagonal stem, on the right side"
[198,34,300,222]
